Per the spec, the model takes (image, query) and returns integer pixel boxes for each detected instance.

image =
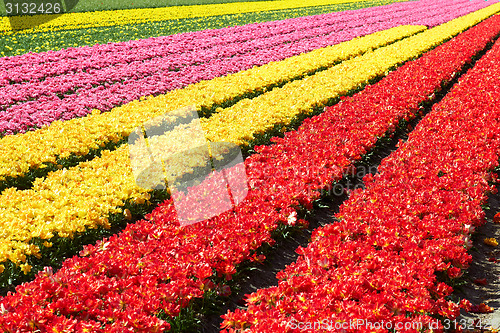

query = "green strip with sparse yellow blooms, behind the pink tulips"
[0,0,396,56]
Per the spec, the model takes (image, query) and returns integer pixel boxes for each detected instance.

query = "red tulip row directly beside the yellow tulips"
[0,16,500,332]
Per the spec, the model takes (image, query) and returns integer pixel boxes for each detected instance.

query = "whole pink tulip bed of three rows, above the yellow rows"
[0,2,488,134]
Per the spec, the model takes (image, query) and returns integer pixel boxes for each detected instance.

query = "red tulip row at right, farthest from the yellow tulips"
[223,19,500,333]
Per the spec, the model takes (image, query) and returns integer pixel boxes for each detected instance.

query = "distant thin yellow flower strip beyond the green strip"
[0,0,363,34]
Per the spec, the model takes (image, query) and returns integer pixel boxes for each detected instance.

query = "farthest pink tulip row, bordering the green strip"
[0,0,490,74]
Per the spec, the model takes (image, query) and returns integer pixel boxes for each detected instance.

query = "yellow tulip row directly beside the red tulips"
[0,4,500,270]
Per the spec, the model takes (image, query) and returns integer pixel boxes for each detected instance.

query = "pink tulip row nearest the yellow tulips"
[0,2,484,134]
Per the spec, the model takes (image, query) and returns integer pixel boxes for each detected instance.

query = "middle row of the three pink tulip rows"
[0,6,430,107]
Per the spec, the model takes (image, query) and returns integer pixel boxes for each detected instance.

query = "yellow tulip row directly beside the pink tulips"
[0,26,425,181]
